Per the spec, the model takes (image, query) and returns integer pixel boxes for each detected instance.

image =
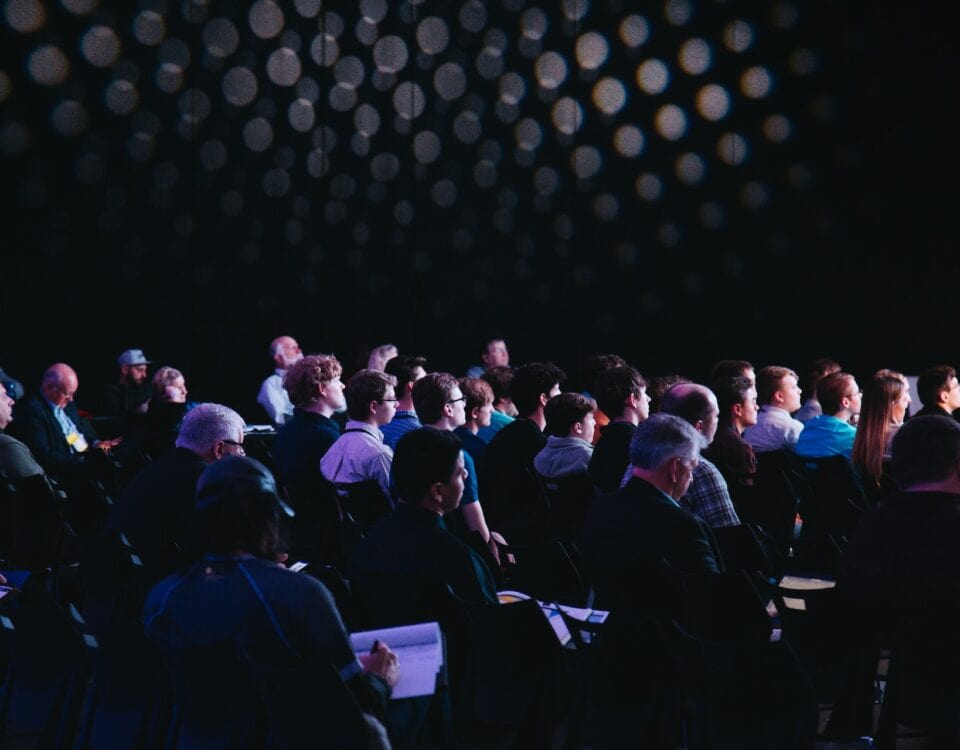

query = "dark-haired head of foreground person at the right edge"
[893,415,960,490]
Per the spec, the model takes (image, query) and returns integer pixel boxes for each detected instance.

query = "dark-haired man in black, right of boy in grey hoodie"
[588,365,650,492]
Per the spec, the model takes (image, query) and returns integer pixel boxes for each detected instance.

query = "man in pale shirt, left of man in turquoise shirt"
[743,365,803,453]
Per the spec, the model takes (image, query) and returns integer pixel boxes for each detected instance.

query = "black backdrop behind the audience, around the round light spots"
[0,0,958,422]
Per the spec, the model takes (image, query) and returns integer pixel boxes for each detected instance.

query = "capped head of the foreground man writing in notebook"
[193,456,281,560]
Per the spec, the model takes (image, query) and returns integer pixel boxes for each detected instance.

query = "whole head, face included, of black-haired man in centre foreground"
[391,427,467,515]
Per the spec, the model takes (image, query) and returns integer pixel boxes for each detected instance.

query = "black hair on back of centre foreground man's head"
[391,428,461,505]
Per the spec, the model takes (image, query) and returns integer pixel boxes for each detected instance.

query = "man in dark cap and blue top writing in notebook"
[143,456,399,736]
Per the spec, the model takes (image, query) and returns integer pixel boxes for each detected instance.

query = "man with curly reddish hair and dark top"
[272,354,347,494]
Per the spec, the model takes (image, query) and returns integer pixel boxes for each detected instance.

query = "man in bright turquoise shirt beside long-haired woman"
[794,372,863,458]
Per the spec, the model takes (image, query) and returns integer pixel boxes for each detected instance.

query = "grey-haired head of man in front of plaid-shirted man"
[630,414,706,500]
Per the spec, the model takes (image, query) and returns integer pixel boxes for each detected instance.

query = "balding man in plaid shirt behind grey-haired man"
[660,383,740,528]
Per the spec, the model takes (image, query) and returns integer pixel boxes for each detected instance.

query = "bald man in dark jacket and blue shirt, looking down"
[13,362,120,478]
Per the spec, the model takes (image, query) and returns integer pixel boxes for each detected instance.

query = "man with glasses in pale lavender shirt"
[320,370,397,506]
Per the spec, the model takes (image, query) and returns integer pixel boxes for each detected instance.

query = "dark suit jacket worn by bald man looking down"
[10,395,97,477]
